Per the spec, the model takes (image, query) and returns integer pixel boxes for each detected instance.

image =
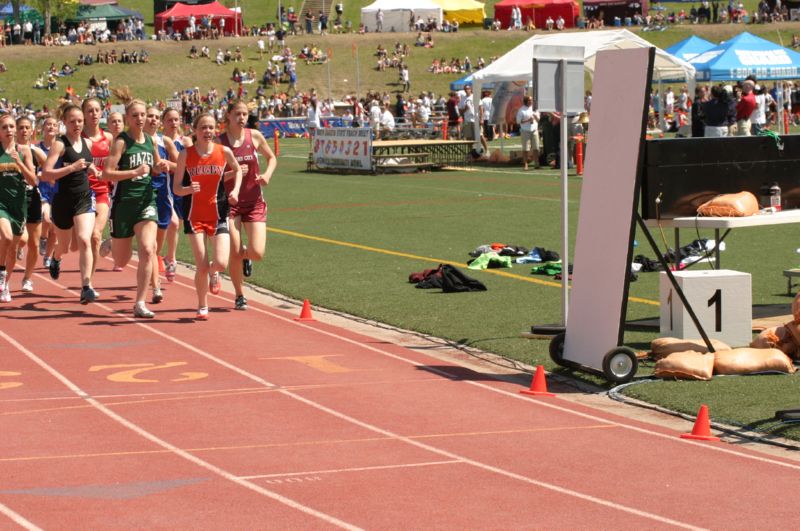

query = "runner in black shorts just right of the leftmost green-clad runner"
[17,116,47,293]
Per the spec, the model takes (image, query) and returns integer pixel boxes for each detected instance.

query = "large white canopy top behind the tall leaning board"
[472,30,695,86]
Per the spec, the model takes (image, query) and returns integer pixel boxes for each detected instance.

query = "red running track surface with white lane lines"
[0,256,800,529]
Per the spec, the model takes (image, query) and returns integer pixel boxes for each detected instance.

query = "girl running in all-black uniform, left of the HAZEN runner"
[42,104,98,304]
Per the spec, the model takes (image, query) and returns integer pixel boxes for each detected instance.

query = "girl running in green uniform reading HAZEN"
[103,100,168,319]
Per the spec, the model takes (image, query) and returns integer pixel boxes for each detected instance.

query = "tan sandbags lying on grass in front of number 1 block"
[650,337,795,380]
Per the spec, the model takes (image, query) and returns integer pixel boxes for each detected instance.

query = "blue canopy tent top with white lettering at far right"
[689,32,800,81]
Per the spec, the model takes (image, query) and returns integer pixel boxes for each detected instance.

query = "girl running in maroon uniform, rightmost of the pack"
[219,101,278,310]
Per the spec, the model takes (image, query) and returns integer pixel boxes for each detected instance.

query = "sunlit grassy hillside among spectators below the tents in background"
[0,21,798,107]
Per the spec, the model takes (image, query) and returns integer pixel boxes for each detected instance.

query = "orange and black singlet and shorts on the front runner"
[183,144,228,236]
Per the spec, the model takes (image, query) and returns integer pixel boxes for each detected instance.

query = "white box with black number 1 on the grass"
[660,269,753,347]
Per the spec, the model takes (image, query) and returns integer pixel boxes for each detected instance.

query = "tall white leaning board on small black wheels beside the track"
[563,48,655,382]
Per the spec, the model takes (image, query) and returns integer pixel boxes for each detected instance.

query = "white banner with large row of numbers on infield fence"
[311,127,372,171]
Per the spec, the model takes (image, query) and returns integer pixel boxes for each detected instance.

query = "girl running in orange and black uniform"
[172,114,242,320]
